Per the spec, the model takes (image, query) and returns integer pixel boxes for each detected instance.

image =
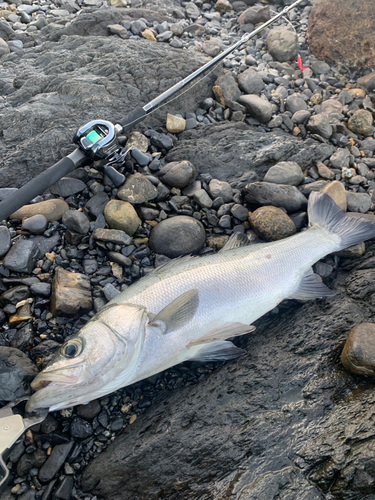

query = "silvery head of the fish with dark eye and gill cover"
[26,303,148,413]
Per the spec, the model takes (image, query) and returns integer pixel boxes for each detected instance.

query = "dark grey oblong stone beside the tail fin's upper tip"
[242,182,307,212]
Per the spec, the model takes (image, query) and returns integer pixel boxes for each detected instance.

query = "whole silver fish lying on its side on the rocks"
[26,192,375,412]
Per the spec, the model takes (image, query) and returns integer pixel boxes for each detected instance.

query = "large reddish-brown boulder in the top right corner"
[307,0,375,70]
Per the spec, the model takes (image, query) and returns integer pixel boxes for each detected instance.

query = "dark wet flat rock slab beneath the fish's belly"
[82,240,375,500]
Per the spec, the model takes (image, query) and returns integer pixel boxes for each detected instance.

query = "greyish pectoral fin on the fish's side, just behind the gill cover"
[151,289,199,333]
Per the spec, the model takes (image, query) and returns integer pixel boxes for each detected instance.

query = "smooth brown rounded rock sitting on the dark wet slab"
[341,323,375,377]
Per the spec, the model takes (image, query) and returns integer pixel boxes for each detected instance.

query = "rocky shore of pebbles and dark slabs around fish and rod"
[0,0,375,500]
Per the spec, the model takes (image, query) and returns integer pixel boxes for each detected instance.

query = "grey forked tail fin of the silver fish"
[307,192,375,251]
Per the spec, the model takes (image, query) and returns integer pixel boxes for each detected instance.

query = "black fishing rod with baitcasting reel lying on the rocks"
[0,0,304,221]
